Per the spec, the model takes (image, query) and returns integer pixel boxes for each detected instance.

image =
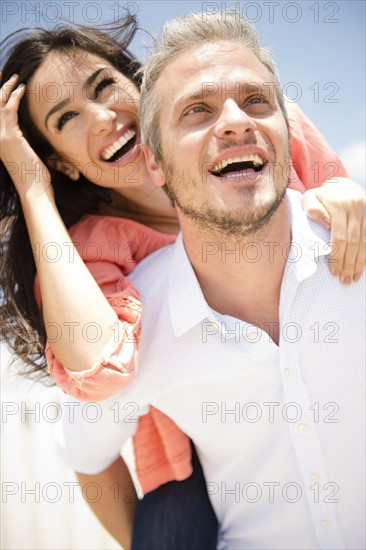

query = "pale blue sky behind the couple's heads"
[1,0,366,183]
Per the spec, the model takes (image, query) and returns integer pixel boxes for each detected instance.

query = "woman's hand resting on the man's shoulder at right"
[302,178,366,285]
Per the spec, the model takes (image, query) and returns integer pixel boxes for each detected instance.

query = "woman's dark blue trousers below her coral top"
[131,445,218,550]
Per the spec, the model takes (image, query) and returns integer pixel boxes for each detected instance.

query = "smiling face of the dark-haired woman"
[27,50,149,190]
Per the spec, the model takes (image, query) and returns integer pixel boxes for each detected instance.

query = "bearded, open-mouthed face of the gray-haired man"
[148,41,290,236]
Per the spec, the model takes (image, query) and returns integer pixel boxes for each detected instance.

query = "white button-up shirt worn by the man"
[60,191,365,550]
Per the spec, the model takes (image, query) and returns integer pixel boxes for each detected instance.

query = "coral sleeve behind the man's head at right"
[286,102,347,192]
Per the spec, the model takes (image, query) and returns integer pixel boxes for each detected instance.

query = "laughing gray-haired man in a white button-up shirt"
[60,10,365,549]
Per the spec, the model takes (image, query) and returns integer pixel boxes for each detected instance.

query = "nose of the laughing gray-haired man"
[215,98,257,139]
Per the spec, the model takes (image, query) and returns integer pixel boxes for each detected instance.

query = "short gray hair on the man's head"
[139,11,287,162]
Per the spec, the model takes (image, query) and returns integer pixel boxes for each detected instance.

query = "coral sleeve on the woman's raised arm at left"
[35,216,175,401]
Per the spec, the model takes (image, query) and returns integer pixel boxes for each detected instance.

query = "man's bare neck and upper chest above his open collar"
[181,200,291,343]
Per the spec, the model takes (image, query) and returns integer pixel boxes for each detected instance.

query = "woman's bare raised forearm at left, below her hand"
[21,191,118,371]
